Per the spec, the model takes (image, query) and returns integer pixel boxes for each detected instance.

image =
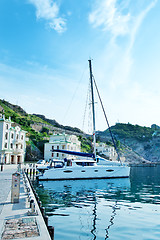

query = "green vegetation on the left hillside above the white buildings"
[0,99,91,159]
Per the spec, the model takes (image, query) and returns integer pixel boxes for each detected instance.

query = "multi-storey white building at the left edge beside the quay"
[0,114,26,164]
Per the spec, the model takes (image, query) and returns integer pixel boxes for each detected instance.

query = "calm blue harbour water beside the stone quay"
[34,166,160,240]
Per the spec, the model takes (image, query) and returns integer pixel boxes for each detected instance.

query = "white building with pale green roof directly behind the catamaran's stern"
[44,133,81,160]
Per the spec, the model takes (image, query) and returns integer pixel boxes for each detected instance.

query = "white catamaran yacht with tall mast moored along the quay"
[37,60,130,180]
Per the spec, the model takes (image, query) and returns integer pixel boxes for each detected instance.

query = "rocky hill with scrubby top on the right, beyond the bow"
[98,123,160,163]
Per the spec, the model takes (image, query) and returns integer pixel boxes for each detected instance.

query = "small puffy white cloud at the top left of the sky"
[28,0,66,33]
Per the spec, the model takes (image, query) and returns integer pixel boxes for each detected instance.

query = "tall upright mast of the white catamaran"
[88,59,96,159]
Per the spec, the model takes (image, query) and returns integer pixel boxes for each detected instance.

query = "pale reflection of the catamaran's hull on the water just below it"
[37,179,130,209]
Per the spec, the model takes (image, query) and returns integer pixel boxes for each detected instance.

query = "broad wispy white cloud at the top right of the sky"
[89,0,157,40]
